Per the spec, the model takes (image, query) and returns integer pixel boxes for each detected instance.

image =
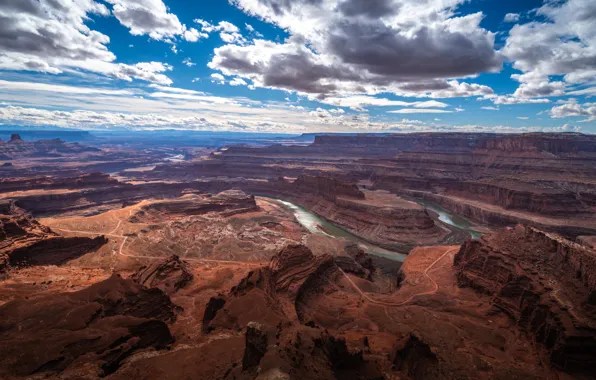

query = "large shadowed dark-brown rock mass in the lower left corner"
[0,275,176,378]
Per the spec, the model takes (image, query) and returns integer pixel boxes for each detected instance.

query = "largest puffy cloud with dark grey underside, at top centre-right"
[209,0,501,99]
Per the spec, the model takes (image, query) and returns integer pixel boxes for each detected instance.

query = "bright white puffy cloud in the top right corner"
[502,0,596,98]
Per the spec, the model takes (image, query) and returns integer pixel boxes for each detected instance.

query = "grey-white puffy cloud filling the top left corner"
[0,0,172,84]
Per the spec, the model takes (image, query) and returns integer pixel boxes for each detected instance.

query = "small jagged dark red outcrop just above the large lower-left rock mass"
[131,255,193,295]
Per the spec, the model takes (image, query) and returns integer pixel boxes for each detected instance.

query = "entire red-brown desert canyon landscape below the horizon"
[0,133,596,380]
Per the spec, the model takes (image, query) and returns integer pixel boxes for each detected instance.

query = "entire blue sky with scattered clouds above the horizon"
[0,0,596,133]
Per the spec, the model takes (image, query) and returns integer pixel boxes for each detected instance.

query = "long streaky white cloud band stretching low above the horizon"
[0,77,586,133]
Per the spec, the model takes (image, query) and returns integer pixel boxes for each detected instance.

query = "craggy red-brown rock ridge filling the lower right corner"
[454,226,596,374]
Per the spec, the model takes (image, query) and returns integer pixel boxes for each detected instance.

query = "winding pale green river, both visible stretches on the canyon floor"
[271,198,482,262]
